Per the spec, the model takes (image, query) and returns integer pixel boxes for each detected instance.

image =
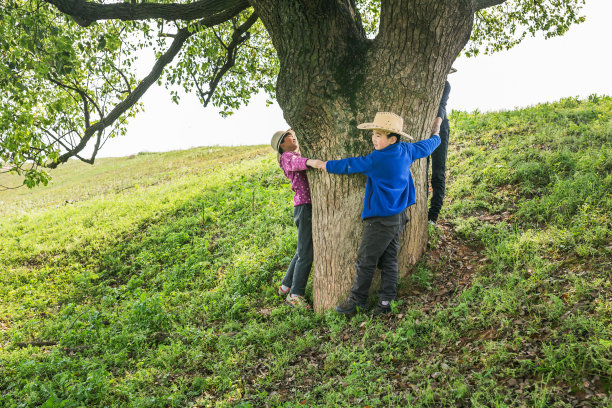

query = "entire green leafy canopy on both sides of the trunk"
[0,0,584,188]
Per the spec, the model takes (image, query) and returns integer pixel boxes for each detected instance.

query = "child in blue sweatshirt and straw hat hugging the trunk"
[314,112,440,315]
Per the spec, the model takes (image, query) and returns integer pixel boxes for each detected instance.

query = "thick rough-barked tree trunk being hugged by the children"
[251,0,473,311]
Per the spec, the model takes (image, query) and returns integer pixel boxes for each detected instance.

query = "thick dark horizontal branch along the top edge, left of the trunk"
[44,0,249,27]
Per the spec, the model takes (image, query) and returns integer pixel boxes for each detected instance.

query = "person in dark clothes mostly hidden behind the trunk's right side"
[426,68,457,224]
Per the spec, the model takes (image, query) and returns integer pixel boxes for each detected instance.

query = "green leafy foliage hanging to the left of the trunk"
[0,0,278,188]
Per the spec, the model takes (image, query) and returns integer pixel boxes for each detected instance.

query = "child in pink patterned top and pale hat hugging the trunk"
[271,129,322,308]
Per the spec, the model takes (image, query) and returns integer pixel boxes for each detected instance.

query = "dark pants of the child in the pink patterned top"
[282,204,313,296]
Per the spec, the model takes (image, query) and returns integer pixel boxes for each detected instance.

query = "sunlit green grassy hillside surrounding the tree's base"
[0,97,612,407]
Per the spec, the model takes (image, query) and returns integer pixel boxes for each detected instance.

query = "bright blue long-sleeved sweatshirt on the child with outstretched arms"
[326,135,440,218]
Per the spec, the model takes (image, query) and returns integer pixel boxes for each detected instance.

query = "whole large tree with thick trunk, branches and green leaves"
[0,0,584,310]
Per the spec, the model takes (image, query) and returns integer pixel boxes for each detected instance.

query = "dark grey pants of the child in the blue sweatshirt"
[351,211,408,304]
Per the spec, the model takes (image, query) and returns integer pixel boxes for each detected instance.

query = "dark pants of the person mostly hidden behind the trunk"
[427,119,450,222]
